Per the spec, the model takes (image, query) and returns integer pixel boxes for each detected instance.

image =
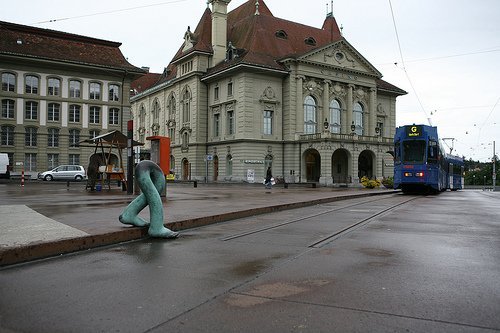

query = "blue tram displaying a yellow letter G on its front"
[394,124,464,193]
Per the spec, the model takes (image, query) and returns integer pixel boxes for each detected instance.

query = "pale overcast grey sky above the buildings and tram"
[0,0,500,161]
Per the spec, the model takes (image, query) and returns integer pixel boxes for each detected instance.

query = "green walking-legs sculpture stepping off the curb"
[119,160,179,238]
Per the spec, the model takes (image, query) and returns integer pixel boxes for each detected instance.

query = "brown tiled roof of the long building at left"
[0,21,144,74]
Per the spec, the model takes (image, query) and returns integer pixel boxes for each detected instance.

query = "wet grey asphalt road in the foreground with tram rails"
[0,191,500,332]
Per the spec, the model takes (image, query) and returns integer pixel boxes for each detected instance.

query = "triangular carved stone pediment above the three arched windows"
[298,40,382,78]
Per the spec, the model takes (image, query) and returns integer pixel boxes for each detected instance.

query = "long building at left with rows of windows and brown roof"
[0,22,145,177]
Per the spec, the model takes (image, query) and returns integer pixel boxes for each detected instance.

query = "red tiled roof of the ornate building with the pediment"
[148,0,406,95]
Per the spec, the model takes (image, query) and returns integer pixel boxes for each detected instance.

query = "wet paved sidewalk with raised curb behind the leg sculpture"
[0,181,393,266]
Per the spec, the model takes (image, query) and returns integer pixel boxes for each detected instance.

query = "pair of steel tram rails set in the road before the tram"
[220,194,422,248]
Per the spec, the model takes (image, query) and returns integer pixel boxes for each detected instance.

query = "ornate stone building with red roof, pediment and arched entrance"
[132,0,406,186]
